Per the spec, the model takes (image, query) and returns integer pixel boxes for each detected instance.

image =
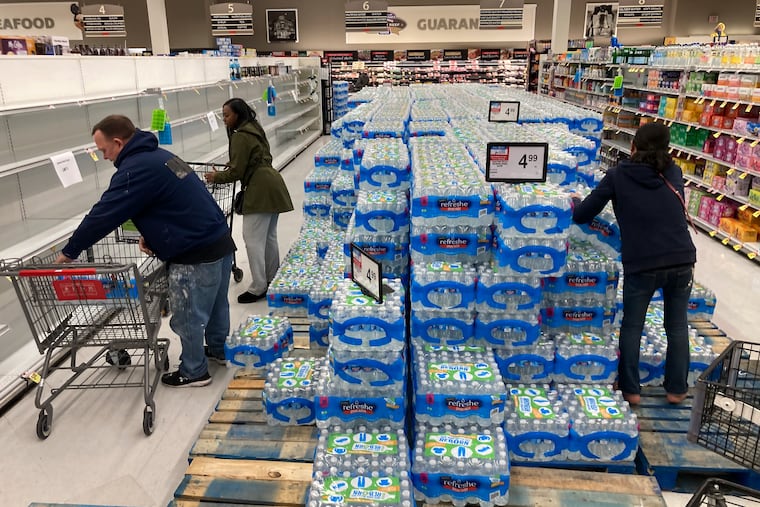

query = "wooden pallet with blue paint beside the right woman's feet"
[633,387,760,492]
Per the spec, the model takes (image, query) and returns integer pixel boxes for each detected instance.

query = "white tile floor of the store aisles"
[0,133,760,507]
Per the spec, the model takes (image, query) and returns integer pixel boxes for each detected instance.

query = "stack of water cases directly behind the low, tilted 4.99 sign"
[344,190,409,280]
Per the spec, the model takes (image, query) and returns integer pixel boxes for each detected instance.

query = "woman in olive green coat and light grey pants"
[206,98,293,303]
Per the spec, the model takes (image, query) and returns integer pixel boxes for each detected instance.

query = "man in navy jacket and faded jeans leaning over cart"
[57,115,235,387]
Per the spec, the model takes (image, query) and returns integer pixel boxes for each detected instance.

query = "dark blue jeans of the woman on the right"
[618,266,694,394]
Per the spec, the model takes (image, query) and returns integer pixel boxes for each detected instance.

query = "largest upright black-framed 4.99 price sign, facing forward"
[486,143,549,183]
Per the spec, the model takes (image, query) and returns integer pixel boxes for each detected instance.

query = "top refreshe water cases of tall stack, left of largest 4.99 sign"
[409,137,494,264]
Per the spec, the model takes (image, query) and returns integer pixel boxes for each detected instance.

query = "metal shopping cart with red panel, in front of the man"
[0,231,169,439]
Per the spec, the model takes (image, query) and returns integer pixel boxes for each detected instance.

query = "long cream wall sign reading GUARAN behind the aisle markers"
[346,4,536,46]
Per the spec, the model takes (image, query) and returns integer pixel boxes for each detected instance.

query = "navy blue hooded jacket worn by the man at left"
[63,130,229,261]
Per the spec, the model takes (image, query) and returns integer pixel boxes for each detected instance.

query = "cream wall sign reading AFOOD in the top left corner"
[0,2,82,40]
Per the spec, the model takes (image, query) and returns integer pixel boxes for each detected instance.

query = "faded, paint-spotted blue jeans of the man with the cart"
[169,254,232,378]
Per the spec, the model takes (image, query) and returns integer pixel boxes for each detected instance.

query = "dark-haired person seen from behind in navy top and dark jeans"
[573,123,697,404]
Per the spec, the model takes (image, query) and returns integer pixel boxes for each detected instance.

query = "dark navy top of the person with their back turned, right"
[573,160,697,274]
